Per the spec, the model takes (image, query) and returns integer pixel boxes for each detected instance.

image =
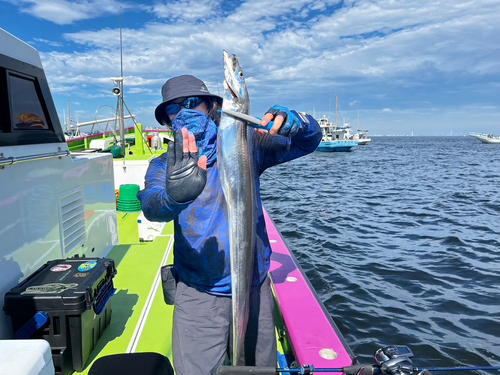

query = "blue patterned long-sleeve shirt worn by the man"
[137,114,321,296]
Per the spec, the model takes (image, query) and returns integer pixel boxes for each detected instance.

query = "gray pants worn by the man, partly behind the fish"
[172,277,277,375]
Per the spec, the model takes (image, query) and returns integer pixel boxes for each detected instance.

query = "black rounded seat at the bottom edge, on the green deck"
[88,353,175,375]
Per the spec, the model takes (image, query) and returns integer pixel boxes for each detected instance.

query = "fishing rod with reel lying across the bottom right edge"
[217,345,500,375]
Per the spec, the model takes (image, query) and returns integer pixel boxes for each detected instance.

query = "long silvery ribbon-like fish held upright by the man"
[217,51,257,366]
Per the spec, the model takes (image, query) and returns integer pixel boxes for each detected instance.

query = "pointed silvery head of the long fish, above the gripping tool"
[223,51,250,113]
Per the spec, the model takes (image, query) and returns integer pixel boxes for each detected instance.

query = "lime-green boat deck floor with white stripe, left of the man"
[75,213,173,374]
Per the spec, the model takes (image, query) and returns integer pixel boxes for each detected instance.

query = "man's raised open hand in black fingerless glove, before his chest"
[166,128,207,203]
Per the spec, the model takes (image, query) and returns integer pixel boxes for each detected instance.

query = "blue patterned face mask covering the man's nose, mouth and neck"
[172,109,217,165]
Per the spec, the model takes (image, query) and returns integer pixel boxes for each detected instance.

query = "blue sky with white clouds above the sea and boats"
[0,0,500,135]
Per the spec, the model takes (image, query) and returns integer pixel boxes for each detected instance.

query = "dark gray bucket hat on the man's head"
[155,75,222,125]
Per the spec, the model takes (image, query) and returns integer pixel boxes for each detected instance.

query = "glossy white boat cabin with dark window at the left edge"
[0,29,117,339]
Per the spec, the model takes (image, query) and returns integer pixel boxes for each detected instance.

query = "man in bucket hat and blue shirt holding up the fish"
[138,75,321,375]
